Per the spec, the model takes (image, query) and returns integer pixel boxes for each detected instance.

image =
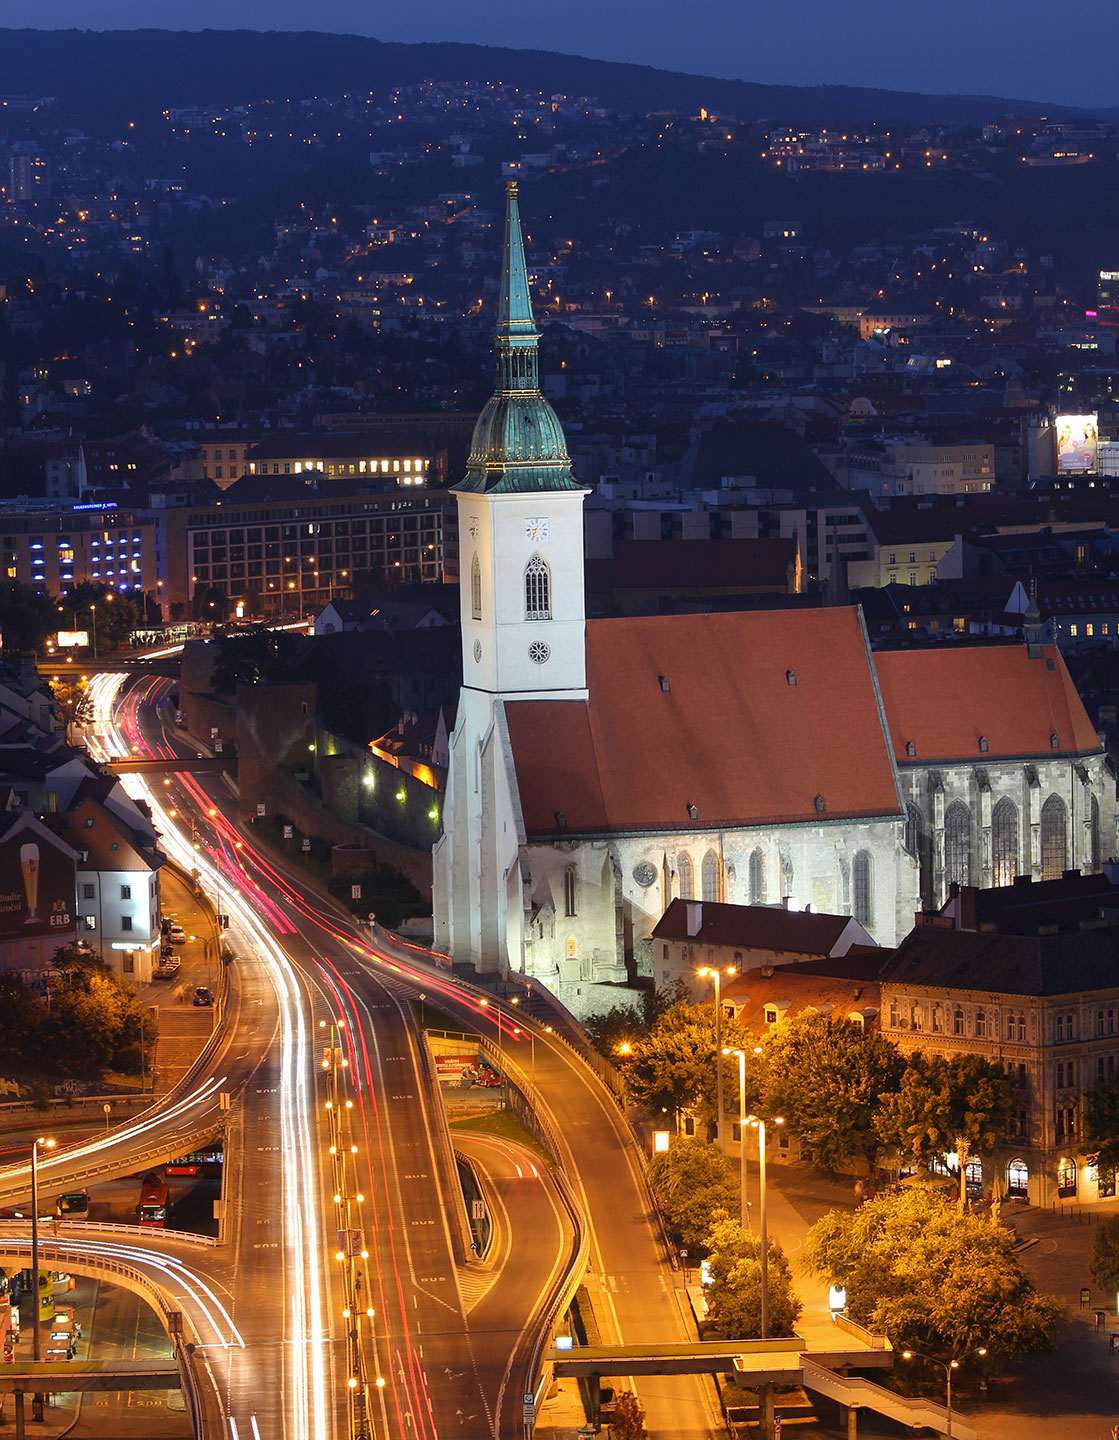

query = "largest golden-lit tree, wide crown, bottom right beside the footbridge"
[804,1189,1063,1358]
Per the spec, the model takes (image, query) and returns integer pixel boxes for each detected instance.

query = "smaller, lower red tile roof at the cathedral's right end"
[874,645,1100,765]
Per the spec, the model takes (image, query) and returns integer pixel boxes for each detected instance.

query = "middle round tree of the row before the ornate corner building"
[762,1011,904,1169]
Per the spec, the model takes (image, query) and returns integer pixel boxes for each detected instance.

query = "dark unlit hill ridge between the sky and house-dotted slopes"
[0,29,1115,127]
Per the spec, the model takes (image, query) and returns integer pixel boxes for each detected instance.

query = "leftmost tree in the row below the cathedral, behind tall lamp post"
[624,1001,753,1123]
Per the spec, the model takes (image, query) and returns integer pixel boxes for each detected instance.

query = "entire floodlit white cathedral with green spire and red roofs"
[433,181,1116,1015]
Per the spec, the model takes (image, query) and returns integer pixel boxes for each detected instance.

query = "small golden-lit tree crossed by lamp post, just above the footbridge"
[704,1212,801,1341]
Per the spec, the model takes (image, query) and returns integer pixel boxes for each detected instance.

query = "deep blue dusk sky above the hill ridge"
[10,0,1119,107]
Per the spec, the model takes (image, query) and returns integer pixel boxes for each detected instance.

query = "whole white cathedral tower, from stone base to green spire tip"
[433,181,586,973]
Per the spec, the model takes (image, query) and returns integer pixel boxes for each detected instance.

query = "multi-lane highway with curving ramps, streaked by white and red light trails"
[0,674,725,1440]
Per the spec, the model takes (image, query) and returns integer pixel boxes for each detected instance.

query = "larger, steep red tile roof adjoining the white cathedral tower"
[505,609,900,835]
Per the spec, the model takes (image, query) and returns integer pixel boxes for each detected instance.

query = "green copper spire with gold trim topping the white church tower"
[454,180,583,494]
